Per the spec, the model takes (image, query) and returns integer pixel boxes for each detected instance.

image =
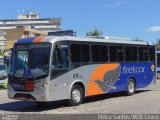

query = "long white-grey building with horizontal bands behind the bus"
[0,12,61,32]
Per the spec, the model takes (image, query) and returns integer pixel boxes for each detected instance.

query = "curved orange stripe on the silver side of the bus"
[86,64,119,96]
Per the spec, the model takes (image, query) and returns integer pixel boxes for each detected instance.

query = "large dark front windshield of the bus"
[10,44,51,78]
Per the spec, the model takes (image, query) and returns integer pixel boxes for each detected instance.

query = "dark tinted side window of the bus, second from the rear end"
[139,47,148,61]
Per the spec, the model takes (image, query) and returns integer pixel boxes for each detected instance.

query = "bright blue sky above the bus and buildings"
[0,0,160,43]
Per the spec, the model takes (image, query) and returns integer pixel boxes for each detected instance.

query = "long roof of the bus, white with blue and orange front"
[16,36,154,45]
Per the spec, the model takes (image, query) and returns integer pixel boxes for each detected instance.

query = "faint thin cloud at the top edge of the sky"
[105,1,127,8]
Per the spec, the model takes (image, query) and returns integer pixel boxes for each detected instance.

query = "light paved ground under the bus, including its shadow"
[0,80,160,114]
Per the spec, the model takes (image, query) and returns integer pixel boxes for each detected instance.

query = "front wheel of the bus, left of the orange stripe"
[68,85,84,106]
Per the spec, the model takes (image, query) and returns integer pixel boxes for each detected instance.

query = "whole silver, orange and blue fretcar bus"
[8,36,155,105]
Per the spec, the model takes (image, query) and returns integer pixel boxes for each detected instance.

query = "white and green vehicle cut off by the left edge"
[0,64,8,88]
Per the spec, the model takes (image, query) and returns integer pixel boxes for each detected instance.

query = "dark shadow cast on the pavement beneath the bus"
[0,90,150,112]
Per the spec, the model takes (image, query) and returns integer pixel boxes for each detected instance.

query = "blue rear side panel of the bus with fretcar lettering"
[109,62,155,93]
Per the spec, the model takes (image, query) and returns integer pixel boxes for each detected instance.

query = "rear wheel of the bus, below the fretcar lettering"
[127,78,135,96]
